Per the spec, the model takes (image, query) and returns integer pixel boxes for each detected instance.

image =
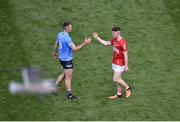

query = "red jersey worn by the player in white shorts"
[111,38,127,66]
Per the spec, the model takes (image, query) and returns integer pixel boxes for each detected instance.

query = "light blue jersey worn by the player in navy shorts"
[56,32,73,61]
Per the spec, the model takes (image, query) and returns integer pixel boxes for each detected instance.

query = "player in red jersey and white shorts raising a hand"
[92,27,131,99]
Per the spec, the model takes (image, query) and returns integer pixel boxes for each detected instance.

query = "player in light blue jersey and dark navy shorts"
[53,22,91,99]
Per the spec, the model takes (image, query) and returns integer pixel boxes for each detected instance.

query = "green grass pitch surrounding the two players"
[0,0,180,120]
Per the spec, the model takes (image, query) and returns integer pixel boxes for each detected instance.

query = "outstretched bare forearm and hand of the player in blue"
[71,38,91,52]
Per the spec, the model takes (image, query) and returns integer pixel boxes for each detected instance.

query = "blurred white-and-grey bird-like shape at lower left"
[9,68,56,95]
